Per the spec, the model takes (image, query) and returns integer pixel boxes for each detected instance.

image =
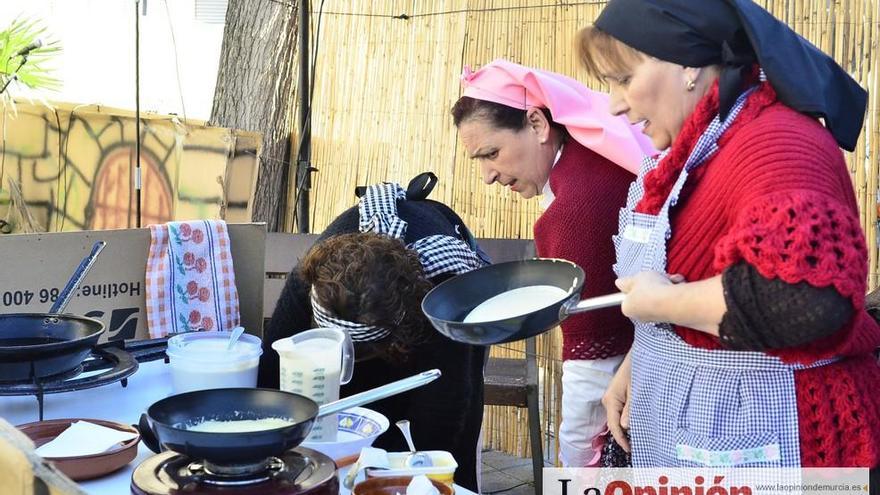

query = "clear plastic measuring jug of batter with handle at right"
[272,328,354,442]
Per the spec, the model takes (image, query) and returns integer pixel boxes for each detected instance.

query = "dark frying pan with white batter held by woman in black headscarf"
[422,258,624,345]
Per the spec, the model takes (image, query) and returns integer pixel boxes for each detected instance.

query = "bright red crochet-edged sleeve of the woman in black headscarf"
[713,106,877,362]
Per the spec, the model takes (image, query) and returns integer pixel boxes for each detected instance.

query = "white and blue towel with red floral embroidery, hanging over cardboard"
[146,220,239,338]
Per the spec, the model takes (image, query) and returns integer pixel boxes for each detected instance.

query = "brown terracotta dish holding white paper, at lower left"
[18,418,141,481]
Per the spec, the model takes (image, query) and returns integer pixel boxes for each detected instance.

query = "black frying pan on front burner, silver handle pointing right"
[138,369,440,465]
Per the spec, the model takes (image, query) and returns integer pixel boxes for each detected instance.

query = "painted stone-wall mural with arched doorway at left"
[0,104,261,233]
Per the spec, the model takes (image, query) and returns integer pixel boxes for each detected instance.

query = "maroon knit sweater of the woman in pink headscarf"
[535,139,635,360]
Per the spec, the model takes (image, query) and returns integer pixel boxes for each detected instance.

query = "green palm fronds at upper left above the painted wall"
[0,18,61,109]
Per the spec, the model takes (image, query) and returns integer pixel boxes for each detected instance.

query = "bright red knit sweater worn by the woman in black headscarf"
[639,83,880,467]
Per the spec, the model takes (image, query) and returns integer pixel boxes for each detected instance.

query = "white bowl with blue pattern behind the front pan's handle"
[302,407,389,460]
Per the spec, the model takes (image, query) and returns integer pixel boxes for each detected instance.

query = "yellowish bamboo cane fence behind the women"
[286,0,880,463]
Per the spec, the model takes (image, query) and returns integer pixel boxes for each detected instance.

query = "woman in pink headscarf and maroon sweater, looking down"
[452,59,654,467]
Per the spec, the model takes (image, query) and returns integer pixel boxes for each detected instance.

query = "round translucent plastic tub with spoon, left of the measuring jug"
[167,332,263,394]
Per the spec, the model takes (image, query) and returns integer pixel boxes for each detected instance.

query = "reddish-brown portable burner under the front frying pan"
[131,447,339,495]
